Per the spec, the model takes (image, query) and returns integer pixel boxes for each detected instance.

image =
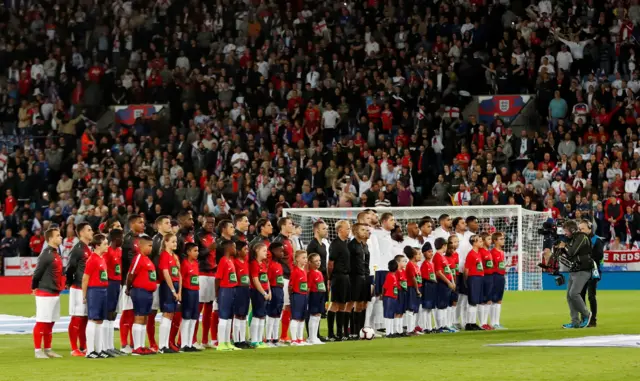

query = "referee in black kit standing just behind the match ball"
[347,223,371,338]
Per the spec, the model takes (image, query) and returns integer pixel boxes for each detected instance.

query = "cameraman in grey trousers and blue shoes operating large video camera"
[559,221,593,328]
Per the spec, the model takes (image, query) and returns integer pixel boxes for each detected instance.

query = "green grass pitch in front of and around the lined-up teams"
[0,291,640,381]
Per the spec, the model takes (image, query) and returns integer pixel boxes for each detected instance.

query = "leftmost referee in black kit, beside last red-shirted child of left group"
[327,220,351,341]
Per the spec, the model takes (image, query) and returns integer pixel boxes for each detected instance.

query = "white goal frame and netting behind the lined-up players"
[283,205,549,290]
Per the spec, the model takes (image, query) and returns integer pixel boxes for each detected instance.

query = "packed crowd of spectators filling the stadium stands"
[0,0,640,268]
